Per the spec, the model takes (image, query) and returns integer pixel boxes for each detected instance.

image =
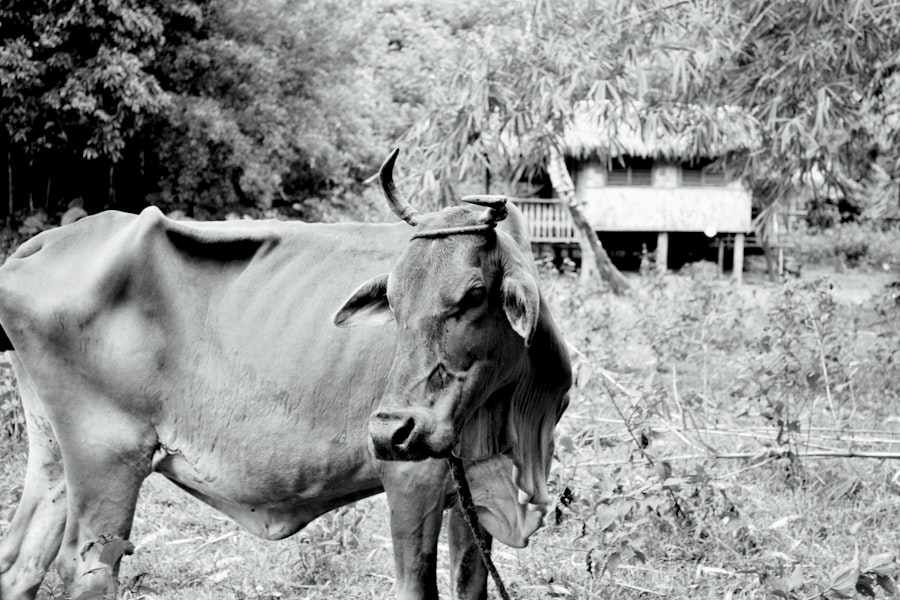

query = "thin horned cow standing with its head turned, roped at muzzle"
[0,150,571,600]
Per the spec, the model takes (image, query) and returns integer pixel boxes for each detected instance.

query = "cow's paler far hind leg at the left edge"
[0,358,66,600]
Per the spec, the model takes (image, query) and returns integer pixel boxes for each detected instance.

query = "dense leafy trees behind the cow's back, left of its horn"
[0,0,397,220]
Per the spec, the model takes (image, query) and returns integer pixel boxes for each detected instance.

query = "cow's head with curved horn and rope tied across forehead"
[334,150,536,460]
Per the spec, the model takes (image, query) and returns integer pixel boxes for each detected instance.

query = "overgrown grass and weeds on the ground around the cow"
[0,269,900,600]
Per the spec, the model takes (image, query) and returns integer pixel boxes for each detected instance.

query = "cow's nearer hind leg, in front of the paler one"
[48,398,156,598]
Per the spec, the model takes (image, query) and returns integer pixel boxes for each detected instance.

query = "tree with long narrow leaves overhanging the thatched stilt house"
[409,0,900,288]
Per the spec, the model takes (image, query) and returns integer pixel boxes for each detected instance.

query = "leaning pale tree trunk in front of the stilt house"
[547,150,631,294]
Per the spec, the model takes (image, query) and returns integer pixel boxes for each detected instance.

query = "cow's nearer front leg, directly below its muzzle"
[381,459,449,600]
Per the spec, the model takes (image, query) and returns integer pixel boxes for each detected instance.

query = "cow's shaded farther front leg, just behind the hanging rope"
[447,500,491,600]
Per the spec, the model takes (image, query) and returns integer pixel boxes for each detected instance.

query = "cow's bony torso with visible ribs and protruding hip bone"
[0,209,409,537]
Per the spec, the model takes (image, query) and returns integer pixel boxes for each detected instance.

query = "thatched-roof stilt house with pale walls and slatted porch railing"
[517,106,759,278]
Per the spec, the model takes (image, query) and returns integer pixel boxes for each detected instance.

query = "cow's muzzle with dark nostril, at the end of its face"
[369,408,456,460]
